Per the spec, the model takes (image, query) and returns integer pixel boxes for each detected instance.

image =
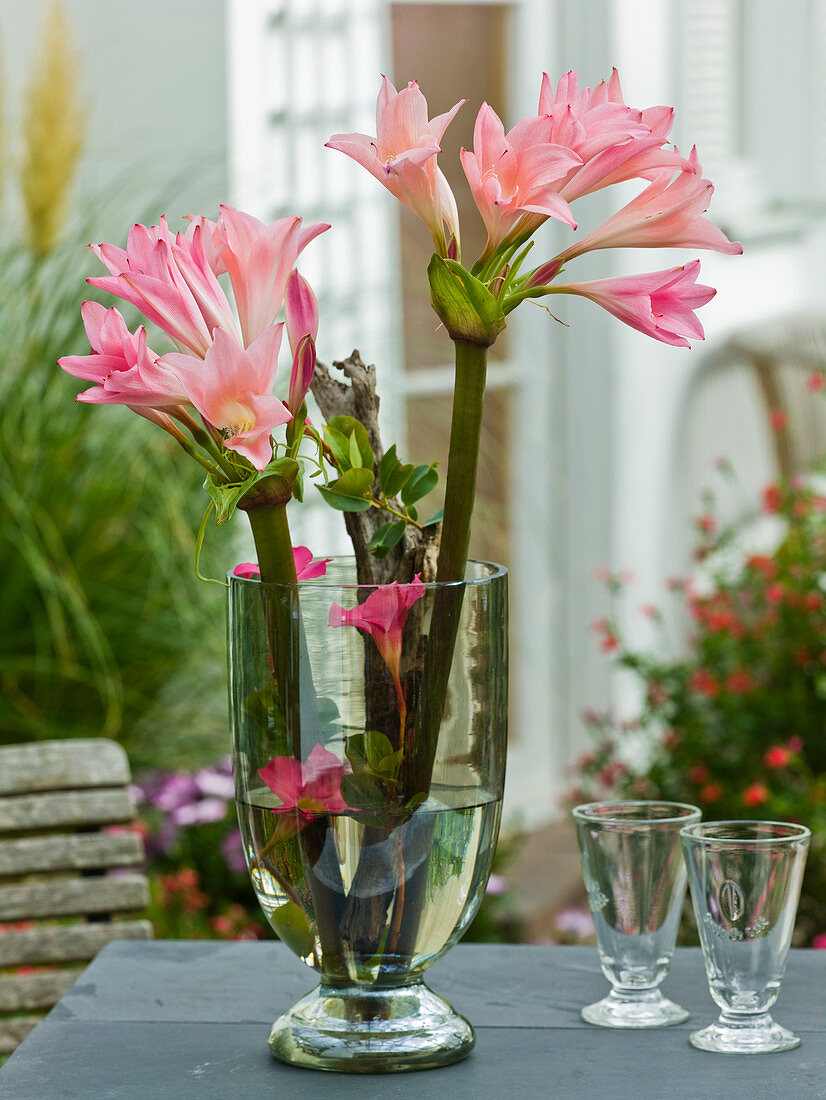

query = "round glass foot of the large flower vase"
[269,981,476,1074]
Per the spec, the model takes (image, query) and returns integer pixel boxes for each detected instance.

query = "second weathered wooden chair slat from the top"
[0,787,134,833]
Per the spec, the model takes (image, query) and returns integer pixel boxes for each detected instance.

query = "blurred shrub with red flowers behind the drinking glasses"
[569,468,826,946]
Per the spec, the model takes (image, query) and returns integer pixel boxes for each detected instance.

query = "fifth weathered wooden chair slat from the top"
[0,921,152,968]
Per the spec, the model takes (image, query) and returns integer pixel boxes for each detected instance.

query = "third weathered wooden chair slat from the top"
[0,833,144,877]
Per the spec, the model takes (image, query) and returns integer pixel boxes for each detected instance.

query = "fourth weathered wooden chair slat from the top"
[0,875,150,921]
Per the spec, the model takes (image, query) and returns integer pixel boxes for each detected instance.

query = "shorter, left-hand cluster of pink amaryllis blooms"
[59,206,330,470]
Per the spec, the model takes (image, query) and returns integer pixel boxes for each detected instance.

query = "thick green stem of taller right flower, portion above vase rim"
[436,340,487,581]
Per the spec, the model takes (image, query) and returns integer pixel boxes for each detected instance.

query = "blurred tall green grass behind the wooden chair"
[0,226,225,765]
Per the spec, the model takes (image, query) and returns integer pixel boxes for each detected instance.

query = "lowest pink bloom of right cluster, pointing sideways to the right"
[543,260,717,348]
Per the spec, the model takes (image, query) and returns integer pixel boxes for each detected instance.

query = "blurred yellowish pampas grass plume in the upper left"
[20,0,85,256]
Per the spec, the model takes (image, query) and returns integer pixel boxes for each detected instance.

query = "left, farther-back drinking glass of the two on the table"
[573,801,701,1027]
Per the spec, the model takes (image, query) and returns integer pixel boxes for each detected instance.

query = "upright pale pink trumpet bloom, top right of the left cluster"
[213,206,330,347]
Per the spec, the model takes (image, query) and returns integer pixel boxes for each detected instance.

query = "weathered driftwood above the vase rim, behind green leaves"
[312,351,441,585]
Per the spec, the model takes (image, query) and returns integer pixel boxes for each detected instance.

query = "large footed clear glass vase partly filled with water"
[230,561,507,1073]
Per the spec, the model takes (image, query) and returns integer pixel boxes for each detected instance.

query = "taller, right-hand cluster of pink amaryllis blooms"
[328,69,742,348]
